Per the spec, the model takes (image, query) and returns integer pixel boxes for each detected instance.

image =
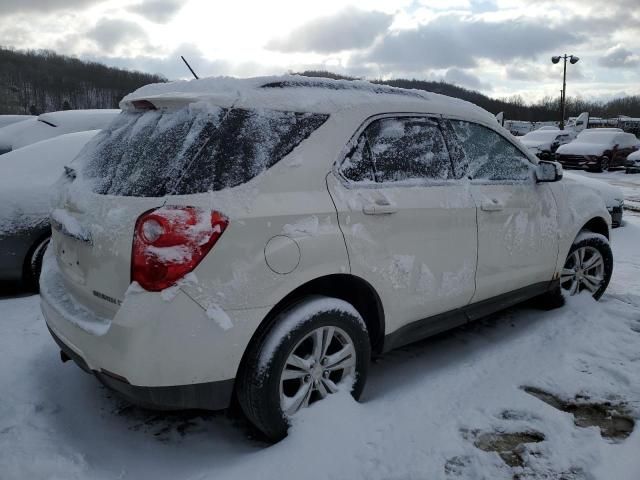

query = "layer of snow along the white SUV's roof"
[120,75,495,124]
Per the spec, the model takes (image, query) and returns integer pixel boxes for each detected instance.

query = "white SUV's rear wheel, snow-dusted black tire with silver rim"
[236,296,371,442]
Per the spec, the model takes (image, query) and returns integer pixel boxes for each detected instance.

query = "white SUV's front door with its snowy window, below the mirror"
[445,119,558,303]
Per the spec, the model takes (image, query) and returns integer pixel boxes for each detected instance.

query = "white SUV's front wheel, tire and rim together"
[560,231,613,300]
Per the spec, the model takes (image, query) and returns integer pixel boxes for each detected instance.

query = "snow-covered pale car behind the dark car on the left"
[0,109,120,154]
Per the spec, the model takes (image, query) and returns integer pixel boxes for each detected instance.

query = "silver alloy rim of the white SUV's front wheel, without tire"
[560,246,605,295]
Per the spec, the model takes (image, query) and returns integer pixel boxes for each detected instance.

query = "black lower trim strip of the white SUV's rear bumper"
[49,327,234,410]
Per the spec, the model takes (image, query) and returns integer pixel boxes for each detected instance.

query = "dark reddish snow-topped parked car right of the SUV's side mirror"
[556,128,640,172]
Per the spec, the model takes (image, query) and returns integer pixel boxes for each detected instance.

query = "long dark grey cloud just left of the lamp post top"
[362,15,581,71]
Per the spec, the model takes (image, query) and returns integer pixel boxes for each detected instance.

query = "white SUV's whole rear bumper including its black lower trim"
[40,249,268,410]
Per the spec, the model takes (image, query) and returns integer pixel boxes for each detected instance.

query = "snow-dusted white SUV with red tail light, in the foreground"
[41,76,613,439]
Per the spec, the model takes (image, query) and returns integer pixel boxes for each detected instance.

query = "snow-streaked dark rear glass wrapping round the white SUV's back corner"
[81,104,328,197]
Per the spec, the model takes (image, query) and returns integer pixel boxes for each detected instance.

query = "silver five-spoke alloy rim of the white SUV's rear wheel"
[280,326,356,417]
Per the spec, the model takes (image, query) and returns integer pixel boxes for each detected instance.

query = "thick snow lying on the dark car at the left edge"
[0,130,98,232]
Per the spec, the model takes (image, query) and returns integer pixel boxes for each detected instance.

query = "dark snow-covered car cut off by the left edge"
[0,130,97,289]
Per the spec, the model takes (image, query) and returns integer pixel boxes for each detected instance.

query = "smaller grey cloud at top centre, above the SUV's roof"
[266,7,393,53]
